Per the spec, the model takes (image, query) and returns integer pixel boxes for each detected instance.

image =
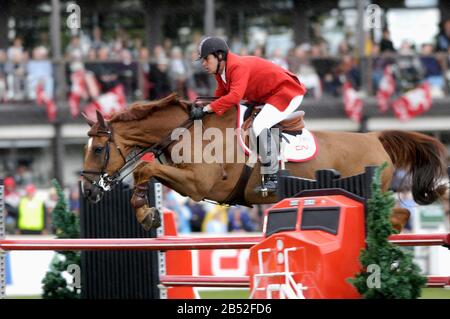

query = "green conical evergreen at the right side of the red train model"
[350,163,427,299]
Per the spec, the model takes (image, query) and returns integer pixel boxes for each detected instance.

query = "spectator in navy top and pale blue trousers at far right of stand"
[420,43,445,97]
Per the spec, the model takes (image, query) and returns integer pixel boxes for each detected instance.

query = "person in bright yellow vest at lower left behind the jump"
[17,184,48,235]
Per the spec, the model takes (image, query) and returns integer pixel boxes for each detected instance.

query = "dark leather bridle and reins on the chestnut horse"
[80,118,194,192]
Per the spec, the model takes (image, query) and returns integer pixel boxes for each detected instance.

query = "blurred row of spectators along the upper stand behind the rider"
[0,20,450,102]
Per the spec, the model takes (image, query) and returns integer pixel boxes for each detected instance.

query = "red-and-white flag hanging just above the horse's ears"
[85,84,127,119]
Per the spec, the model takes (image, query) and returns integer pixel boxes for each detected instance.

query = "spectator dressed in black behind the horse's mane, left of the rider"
[149,56,172,100]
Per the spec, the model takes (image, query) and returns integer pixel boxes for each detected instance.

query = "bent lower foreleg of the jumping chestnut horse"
[131,163,161,231]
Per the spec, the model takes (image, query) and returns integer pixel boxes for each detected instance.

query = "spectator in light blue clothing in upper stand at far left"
[27,46,53,100]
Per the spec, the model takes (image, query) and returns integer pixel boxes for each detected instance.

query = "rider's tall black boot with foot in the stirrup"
[255,128,279,197]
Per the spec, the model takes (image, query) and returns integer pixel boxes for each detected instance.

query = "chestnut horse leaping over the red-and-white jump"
[82,94,447,231]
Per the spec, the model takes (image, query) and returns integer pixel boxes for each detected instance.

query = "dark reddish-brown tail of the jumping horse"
[378,131,447,205]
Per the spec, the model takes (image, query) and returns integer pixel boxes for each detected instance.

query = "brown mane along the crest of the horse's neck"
[109,93,189,123]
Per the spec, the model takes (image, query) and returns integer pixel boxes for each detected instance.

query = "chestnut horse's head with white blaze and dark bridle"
[81,111,126,203]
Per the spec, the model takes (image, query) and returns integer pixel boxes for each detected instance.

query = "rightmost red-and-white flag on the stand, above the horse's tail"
[392,83,432,121]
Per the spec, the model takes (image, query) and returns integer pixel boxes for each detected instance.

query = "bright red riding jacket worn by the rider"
[211,52,306,115]
